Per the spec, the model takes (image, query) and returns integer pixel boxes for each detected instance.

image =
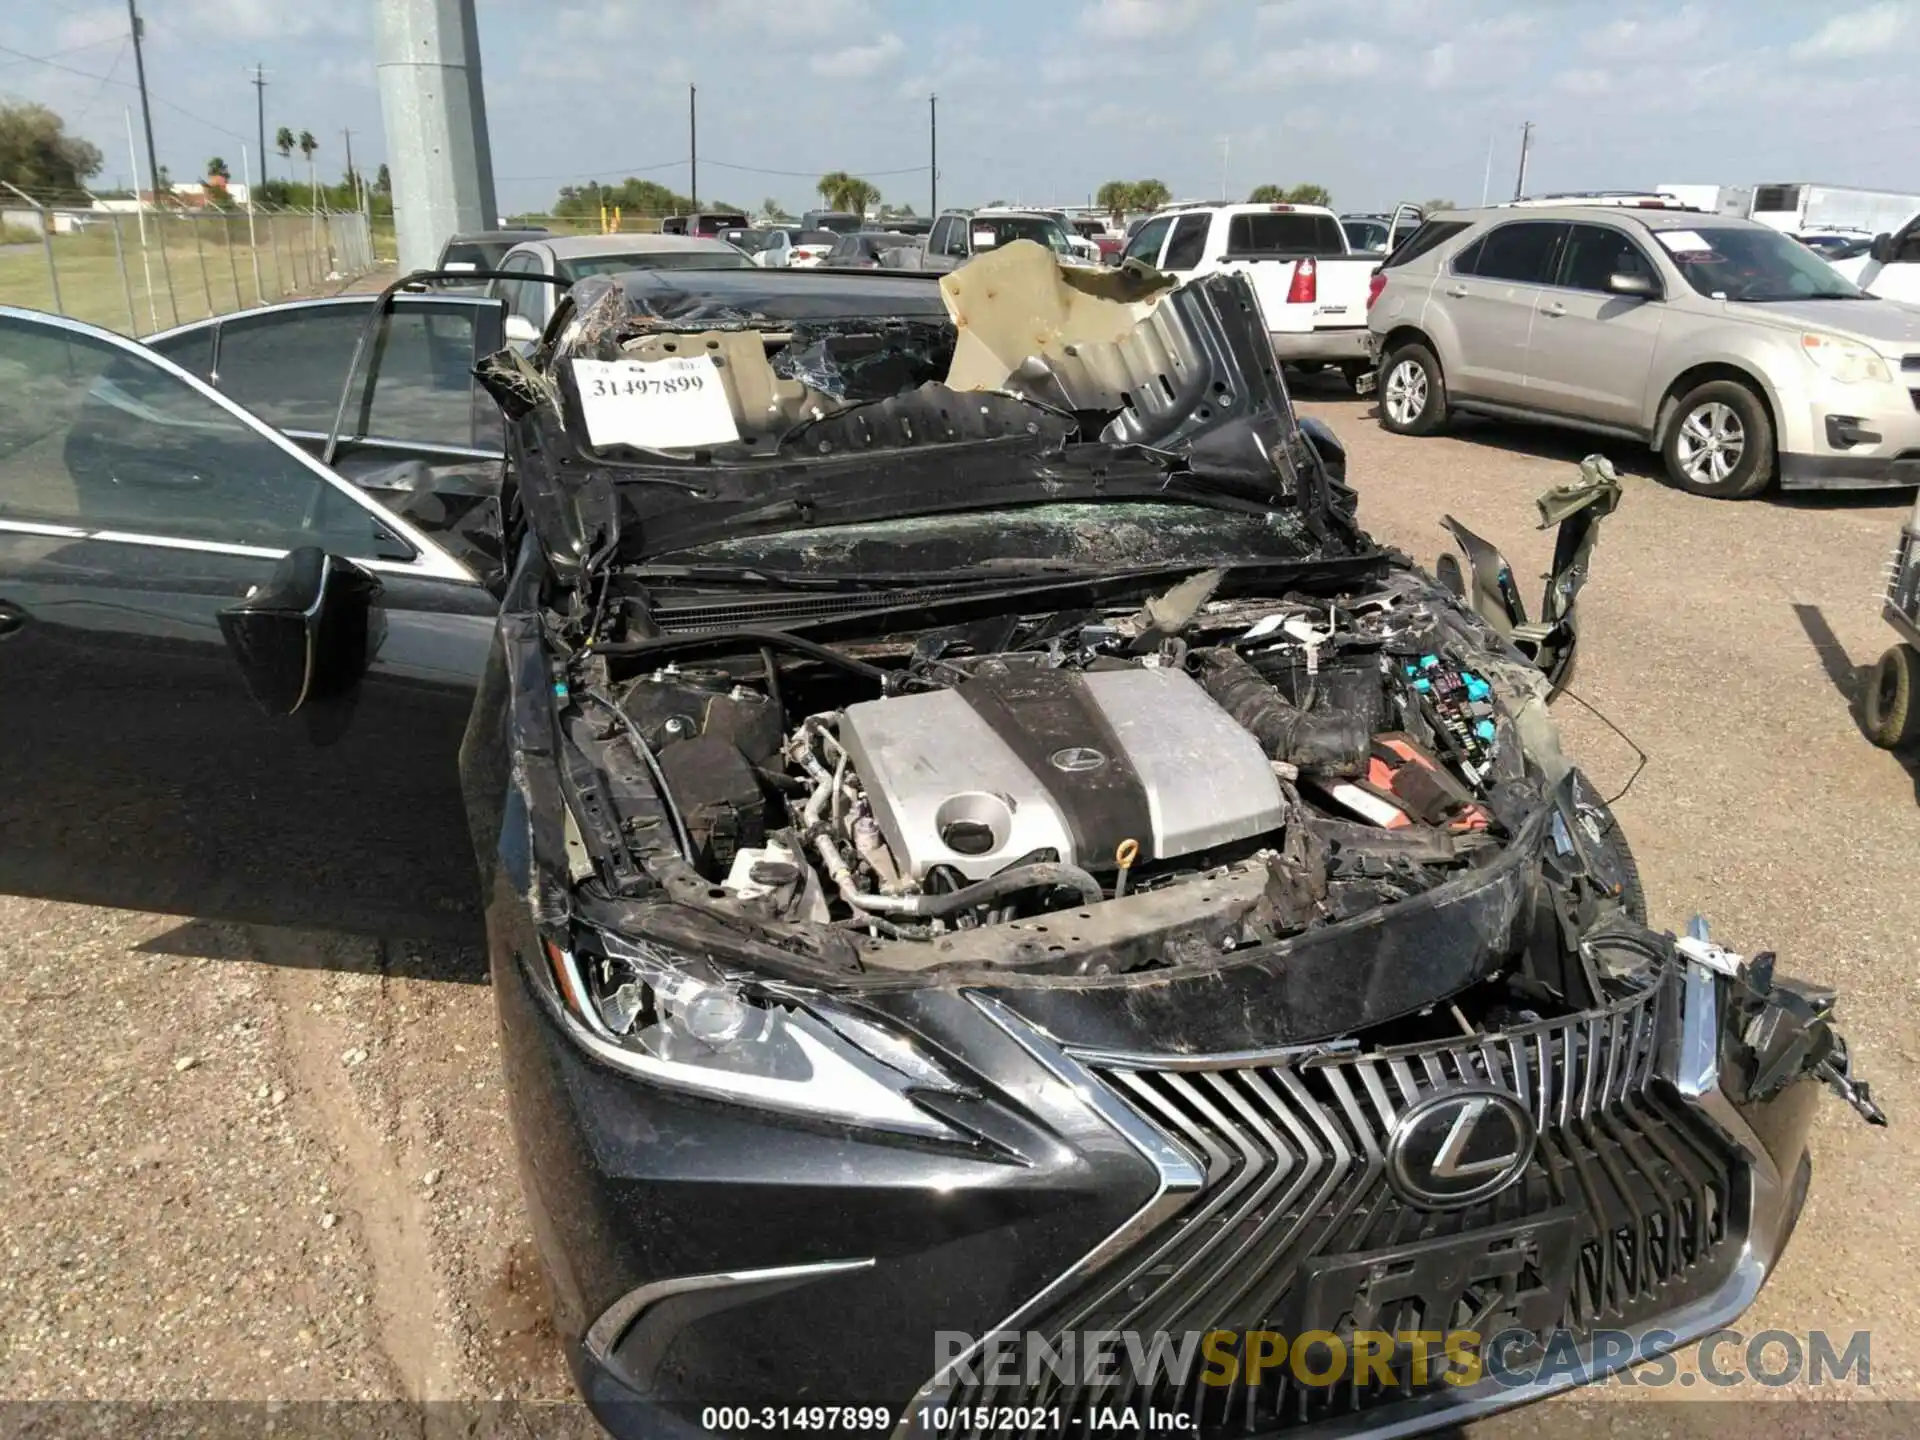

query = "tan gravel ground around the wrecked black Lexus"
[0,368,1920,1436]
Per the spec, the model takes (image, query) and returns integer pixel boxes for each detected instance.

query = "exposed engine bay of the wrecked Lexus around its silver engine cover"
[572,570,1632,973]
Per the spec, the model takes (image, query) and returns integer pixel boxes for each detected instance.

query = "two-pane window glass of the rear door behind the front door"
[219,301,474,445]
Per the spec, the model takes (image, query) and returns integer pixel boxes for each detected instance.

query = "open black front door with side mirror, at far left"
[0,307,497,935]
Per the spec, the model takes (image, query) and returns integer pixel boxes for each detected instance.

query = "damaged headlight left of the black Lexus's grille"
[545,931,962,1139]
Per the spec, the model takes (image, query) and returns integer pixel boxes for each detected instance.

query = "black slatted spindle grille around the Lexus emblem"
[952,987,1740,1434]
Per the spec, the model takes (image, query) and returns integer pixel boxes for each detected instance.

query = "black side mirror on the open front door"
[221,545,380,714]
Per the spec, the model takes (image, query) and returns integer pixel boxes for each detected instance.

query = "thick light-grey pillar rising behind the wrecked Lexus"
[378,0,499,273]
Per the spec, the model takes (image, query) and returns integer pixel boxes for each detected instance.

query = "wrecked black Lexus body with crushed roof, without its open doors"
[463,246,1874,1434]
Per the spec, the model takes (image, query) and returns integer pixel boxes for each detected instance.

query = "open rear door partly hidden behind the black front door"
[146,292,507,582]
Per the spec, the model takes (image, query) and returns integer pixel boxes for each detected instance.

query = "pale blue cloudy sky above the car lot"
[0,0,1920,209]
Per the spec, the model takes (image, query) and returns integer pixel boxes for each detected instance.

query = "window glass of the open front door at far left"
[0,317,411,559]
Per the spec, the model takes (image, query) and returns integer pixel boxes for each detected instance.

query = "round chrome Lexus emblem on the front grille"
[1386,1089,1534,1210]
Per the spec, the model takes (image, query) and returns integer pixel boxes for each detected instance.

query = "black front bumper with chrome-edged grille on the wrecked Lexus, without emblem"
[493,906,1816,1434]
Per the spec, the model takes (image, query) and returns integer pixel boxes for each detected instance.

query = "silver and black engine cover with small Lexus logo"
[841,666,1286,879]
